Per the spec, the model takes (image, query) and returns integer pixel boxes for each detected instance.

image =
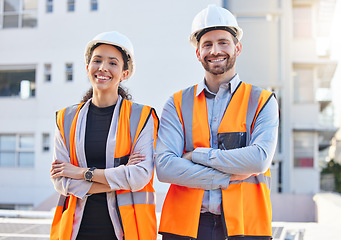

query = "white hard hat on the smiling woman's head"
[85,31,135,79]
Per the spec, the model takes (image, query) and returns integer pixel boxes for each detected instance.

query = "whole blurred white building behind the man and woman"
[0,0,337,220]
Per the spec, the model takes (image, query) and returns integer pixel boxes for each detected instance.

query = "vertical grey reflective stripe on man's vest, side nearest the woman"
[181,86,195,152]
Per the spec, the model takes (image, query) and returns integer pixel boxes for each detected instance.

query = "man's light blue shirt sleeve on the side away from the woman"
[192,97,279,174]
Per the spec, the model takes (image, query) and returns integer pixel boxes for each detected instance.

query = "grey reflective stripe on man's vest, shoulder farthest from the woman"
[246,86,263,146]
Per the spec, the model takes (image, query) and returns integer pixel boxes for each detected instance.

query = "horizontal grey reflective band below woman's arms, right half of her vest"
[117,192,155,207]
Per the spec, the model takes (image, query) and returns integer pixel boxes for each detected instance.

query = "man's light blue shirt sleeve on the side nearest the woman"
[155,97,230,190]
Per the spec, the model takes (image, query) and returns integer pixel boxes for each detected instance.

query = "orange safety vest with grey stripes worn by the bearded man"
[159,83,273,239]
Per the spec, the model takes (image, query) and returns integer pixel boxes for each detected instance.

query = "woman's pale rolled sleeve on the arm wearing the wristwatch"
[105,117,154,192]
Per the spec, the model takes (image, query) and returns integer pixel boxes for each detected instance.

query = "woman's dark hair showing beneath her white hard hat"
[81,43,132,102]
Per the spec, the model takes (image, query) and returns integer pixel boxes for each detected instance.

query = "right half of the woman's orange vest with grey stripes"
[114,100,158,240]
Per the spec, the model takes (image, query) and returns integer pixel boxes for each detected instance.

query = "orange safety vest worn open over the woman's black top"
[50,99,159,240]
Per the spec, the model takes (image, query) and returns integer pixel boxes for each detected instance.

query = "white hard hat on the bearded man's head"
[189,5,243,47]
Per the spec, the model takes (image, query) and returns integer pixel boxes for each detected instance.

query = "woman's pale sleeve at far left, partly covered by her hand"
[52,127,92,199]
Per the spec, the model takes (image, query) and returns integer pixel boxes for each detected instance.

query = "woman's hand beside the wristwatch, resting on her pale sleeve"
[50,159,86,179]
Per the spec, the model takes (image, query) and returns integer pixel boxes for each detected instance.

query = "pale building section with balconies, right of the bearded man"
[225,0,337,221]
